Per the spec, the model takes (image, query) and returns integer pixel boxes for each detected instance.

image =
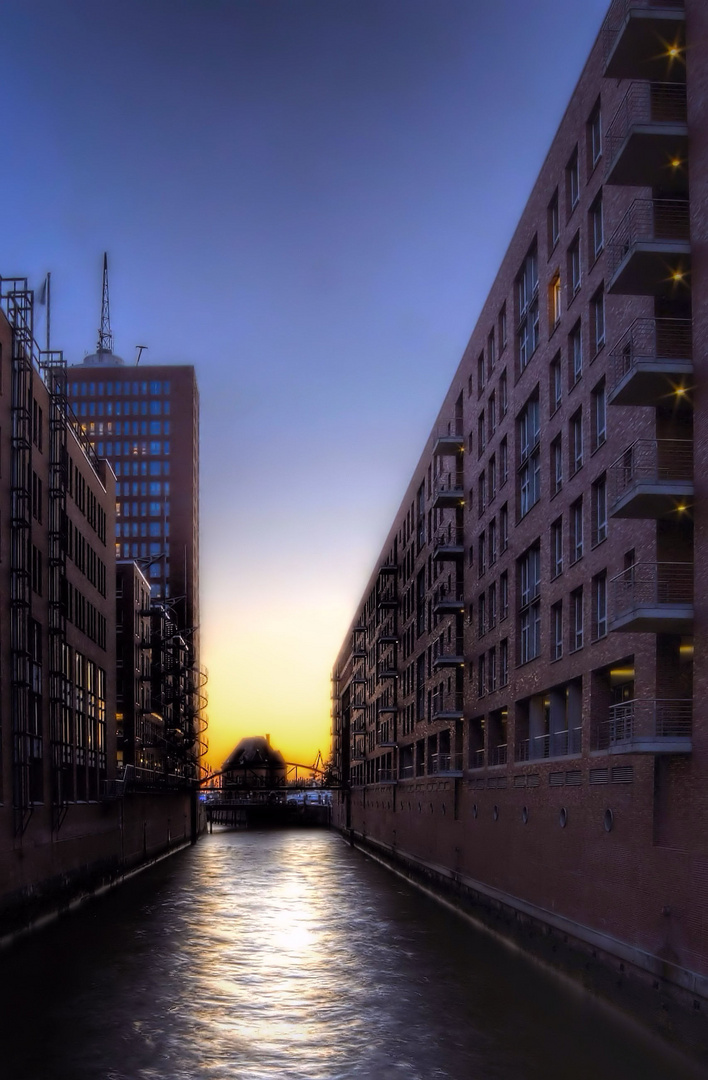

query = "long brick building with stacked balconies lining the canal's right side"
[332,0,708,1000]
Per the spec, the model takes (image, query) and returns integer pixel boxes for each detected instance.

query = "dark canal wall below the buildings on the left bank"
[0,792,206,948]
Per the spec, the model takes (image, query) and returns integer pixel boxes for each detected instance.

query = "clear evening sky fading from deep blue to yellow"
[0,0,607,768]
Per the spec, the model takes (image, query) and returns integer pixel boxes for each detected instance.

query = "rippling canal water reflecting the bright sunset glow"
[0,831,696,1080]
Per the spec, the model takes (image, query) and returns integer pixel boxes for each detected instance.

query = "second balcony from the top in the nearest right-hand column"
[605,82,689,192]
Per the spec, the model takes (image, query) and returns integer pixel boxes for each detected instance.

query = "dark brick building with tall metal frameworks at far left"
[0,279,115,910]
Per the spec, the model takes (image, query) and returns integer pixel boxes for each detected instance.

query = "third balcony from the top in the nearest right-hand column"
[608,199,691,296]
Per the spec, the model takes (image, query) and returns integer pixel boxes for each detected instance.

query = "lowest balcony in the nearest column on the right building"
[599,698,693,754]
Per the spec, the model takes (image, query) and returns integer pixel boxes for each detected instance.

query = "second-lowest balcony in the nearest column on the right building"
[610,563,693,634]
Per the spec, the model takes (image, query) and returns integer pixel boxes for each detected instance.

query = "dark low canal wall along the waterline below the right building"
[339,827,708,1058]
